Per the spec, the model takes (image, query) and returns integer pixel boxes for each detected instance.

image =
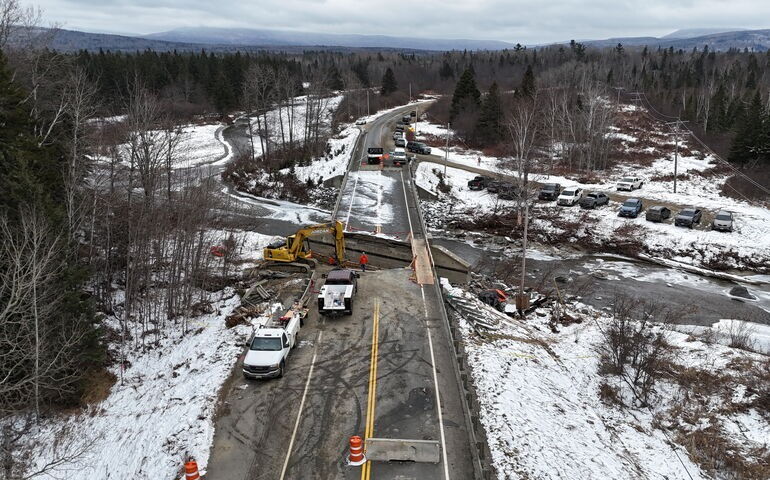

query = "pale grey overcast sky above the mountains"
[31,0,770,44]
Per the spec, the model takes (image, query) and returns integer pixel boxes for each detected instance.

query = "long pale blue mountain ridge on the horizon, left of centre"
[144,27,514,50]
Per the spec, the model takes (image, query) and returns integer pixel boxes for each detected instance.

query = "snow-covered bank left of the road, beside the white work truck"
[18,231,275,480]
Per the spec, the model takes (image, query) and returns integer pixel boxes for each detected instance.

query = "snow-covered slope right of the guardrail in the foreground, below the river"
[445,286,770,480]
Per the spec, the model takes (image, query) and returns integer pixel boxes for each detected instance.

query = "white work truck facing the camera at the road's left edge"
[243,311,302,378]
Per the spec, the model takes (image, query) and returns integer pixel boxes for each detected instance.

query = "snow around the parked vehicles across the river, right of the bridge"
[416,112,770,268]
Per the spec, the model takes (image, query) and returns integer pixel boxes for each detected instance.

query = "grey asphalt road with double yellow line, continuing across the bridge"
[206,107,474,480]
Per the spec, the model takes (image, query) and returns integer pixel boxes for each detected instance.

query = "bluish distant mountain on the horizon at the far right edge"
[582,29,770,52]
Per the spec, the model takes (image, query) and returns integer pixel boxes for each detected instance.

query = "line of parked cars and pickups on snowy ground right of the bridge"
[468,175,735,232]
